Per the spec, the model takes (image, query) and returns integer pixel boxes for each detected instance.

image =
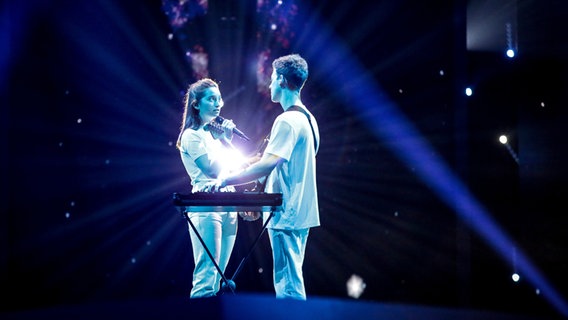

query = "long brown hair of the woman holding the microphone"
[176,78,219,149]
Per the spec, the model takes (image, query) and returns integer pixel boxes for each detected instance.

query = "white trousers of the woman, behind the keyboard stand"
[188,212,238,298]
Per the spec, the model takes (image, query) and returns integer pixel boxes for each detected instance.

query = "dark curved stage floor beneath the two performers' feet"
[0,294,547,320]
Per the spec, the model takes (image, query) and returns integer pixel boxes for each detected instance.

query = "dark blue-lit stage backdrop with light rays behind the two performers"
[0,0,568,317]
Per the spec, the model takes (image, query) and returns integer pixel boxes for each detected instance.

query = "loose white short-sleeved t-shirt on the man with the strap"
[264,111,320,230]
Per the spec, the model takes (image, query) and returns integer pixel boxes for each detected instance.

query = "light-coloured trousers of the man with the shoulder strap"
[268,229,309,300]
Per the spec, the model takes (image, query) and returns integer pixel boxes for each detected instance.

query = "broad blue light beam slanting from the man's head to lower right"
[298,5,568,316]
